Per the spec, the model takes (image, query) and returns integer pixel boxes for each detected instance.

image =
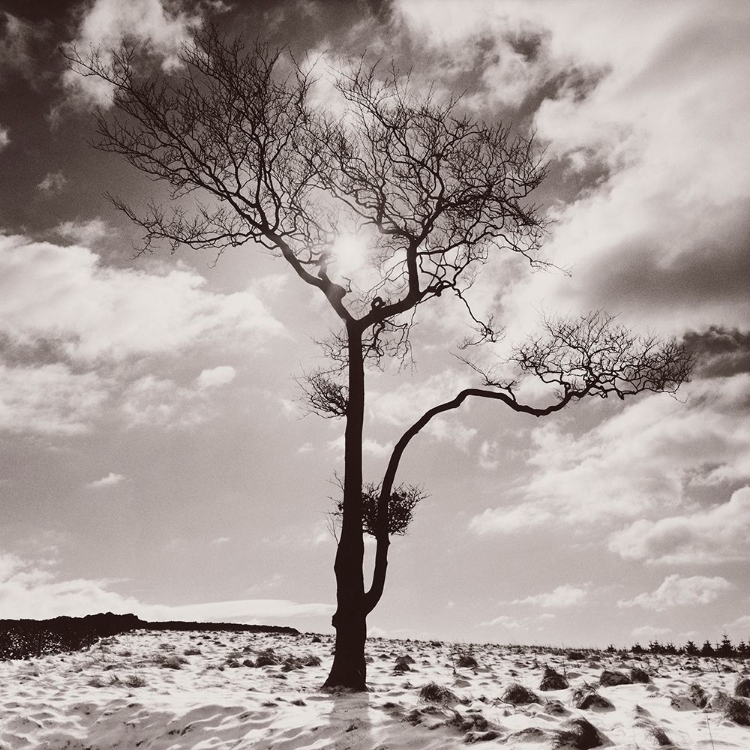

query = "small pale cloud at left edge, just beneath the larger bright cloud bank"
[0,363,111,435]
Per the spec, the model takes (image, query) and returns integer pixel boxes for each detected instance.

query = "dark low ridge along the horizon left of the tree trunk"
[0,612,299,660]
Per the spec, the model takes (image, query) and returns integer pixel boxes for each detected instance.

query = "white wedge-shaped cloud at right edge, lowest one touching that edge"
[609,487,750,565]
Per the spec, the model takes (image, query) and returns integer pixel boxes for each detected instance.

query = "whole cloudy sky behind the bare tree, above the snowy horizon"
[0,0,750,646]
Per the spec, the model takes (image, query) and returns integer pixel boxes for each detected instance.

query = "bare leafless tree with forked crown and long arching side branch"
[66,27,689,690]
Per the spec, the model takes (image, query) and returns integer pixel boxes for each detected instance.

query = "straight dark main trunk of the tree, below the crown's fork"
[323,325,367,691]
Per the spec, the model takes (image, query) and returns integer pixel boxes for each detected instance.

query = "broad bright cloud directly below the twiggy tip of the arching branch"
[470,373,750,541]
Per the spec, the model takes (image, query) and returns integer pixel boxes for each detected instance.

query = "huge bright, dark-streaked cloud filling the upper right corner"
[395,0,750,334]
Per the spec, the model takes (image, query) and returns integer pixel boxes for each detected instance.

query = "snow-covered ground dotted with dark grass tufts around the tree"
[0,631,750,750]
